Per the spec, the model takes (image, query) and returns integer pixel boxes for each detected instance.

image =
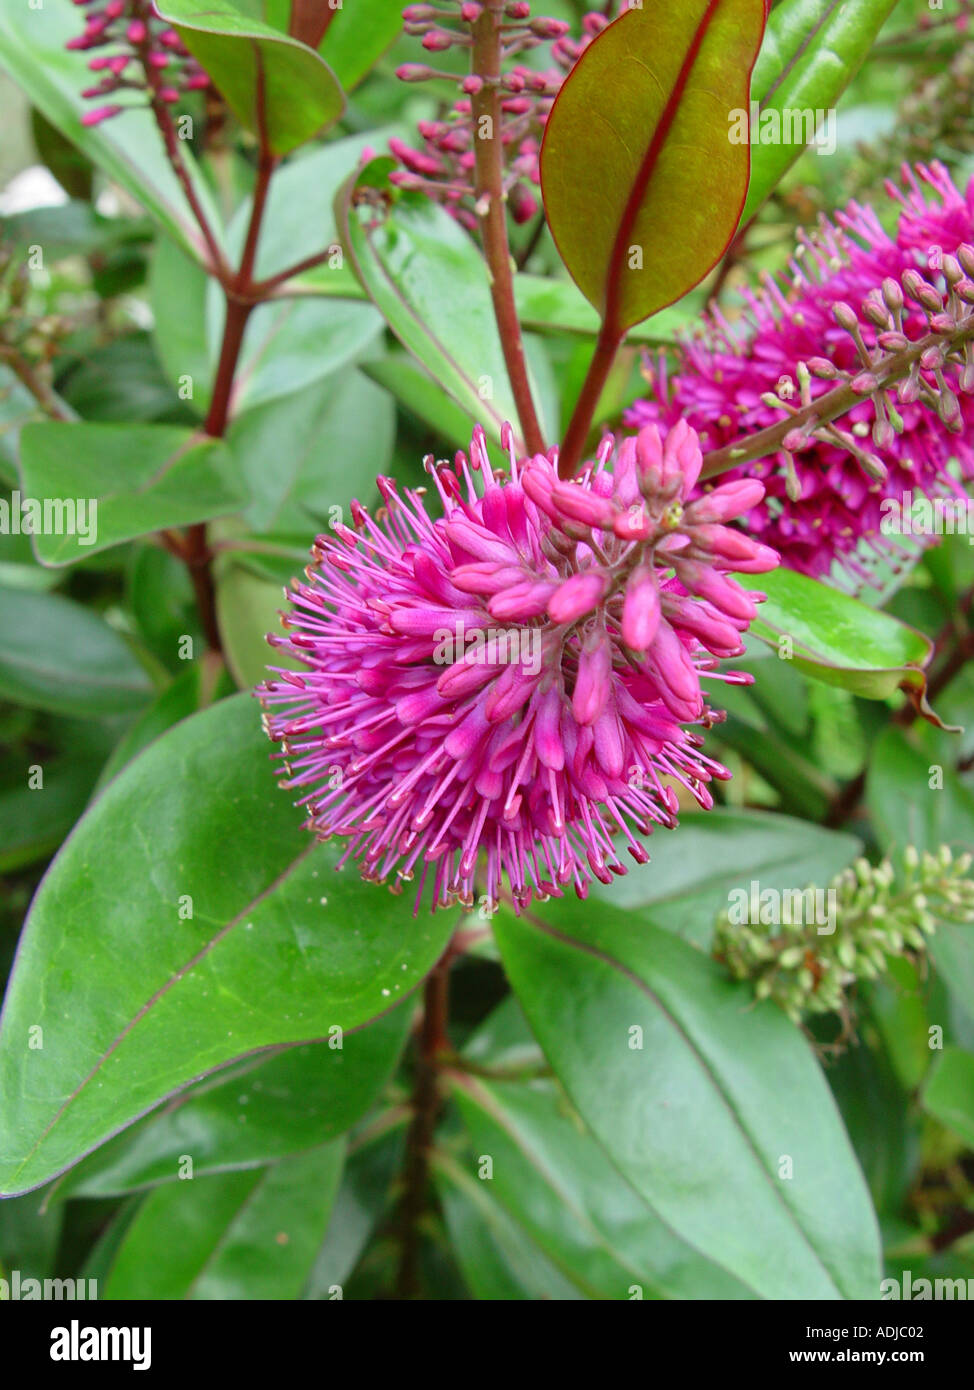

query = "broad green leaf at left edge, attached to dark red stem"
[21,421,247,564]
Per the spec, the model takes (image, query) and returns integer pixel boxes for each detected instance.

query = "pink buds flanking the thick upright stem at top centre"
[389,0,609,231]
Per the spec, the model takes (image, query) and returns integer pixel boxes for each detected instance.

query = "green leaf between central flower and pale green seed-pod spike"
[572,808,863,949]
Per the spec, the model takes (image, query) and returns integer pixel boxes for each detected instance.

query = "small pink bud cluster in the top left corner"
[67,0,210,125]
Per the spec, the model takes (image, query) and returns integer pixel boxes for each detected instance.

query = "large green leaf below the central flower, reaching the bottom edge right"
[495,902,880,1298]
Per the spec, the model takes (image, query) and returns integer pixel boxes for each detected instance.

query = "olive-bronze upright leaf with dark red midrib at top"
[540,0,766,338]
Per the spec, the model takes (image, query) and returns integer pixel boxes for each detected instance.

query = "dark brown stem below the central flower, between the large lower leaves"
[395,947,453,1298]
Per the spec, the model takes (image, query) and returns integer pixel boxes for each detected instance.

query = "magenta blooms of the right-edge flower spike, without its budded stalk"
[625,164,974,581]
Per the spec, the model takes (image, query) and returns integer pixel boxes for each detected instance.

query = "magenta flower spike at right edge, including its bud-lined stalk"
[625,164,974,584]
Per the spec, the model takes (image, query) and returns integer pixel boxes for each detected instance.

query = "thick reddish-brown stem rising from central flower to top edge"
[471,0,545,453]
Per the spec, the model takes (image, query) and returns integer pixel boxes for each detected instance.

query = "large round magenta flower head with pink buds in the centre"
[257,423,777,908]
